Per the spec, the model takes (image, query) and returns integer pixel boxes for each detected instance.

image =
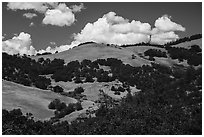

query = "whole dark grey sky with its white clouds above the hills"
[2,2,202,55]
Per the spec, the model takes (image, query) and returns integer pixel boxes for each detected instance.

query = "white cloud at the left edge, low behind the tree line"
[2,32,36,55]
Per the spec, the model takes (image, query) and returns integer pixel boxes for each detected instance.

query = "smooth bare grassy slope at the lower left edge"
[2,80,76,119]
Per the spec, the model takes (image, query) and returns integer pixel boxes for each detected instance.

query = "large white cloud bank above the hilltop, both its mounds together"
[74,12,185,45]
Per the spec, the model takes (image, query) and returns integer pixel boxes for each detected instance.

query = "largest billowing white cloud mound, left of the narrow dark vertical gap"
[74,12,151,45]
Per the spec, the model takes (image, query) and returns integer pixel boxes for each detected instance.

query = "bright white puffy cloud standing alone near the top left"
[42,3,75,27]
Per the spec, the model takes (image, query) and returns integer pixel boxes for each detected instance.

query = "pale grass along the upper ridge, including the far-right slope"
[32,39,202,66]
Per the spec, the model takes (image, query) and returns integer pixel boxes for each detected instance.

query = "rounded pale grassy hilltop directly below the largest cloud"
[32,43,150,66]
